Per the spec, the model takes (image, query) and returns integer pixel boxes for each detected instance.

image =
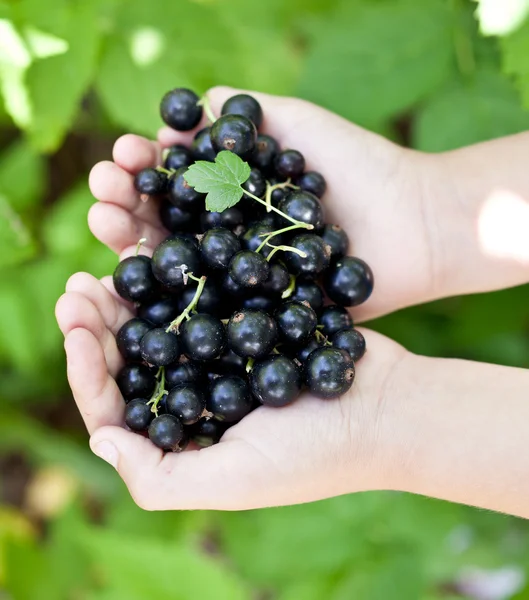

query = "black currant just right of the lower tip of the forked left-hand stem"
[180,313,226,361]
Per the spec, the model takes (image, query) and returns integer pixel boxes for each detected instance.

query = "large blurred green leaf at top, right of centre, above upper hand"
[299,0,453,127]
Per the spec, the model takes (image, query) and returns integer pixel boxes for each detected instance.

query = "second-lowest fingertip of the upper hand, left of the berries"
[88,161,160,227]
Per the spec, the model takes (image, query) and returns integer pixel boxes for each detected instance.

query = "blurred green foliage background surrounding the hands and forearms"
[0,0,529,600]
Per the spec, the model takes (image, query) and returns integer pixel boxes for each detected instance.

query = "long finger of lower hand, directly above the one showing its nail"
[64,328,125,433]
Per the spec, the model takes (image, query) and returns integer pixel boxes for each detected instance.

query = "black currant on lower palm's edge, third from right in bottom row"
[207,375,253,423]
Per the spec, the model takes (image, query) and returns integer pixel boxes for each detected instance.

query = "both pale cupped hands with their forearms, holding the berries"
[56,88,529,516]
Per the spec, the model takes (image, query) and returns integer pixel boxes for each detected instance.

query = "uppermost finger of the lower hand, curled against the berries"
[66,273,133,335]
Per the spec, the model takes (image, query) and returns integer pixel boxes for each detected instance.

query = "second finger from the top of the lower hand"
[55,292,123,376]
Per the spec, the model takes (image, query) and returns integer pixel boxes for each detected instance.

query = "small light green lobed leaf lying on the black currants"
[184,150,250,212]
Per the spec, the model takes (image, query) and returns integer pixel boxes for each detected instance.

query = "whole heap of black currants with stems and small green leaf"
[114,88,373,451]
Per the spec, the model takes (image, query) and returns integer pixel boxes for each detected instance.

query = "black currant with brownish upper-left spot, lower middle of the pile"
[228,309,277,358]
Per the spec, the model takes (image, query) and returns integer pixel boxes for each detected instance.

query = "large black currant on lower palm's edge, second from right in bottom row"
[250,354,301,407]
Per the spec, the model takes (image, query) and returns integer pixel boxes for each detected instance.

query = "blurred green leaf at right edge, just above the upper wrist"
[414,71,529,152]
